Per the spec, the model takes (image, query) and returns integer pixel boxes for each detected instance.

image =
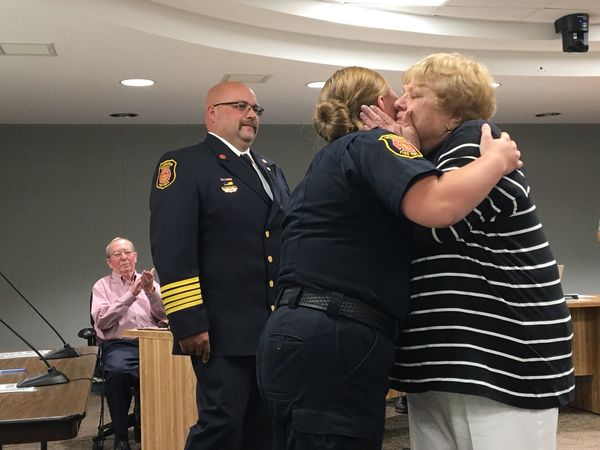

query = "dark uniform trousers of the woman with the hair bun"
[256,305,394,450]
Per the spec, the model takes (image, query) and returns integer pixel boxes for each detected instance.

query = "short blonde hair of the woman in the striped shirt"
[402,53,496,122]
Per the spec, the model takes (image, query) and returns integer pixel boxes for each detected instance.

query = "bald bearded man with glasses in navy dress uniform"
[150,82,289,450]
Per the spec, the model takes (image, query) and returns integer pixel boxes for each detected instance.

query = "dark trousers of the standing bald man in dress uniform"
[185,355,272,450]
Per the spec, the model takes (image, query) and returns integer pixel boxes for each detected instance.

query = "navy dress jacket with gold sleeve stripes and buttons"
[150,134,289,356]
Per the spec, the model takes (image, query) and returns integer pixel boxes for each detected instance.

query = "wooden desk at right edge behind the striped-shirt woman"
[567,295,600,414]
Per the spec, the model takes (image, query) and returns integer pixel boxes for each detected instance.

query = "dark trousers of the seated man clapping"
[101,339,140,438]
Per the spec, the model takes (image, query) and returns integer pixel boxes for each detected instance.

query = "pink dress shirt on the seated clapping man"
[91,271,167,343]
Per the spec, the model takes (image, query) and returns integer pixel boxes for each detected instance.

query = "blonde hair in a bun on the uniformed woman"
[313,66,391,142]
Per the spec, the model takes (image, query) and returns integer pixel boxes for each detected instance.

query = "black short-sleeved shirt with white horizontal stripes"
[390,121,575,409]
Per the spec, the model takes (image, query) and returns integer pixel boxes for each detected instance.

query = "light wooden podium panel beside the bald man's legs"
[124,328,198,450]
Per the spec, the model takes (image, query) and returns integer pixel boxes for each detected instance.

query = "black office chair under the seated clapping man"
[77,296,141,450]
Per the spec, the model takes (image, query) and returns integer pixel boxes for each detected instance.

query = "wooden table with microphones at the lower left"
[0,347,98,449]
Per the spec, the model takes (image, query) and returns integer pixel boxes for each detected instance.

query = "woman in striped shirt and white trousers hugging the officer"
[363,53,574,450]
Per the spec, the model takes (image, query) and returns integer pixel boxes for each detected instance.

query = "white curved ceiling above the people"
[0,0,600,124]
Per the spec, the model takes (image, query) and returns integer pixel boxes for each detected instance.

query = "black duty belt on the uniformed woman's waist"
[276,286,396,337]
